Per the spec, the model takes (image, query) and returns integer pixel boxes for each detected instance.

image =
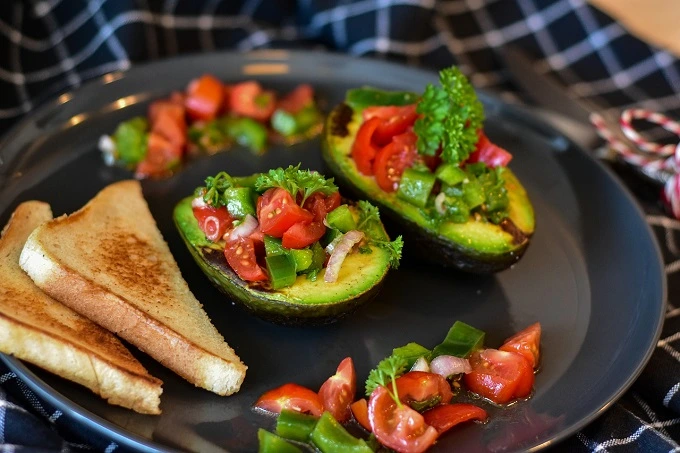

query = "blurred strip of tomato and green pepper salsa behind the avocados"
[99,74,323,178]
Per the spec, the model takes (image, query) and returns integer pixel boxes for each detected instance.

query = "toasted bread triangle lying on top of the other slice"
[20,181,246,395]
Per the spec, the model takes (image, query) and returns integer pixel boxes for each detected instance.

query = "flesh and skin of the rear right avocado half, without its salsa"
[322,104,535,274]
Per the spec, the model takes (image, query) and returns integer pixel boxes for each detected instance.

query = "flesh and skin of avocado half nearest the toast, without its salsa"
[173,197,390,325]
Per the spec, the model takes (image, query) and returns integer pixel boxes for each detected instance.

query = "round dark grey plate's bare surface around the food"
[0,51,665,452]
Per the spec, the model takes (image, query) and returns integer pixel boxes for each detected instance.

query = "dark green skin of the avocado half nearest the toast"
[173,199,387,326]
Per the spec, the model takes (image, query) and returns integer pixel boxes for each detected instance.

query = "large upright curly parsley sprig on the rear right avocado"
[413,66,484,164]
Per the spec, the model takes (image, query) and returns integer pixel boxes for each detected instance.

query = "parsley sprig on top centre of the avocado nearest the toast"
[255,164,338,206]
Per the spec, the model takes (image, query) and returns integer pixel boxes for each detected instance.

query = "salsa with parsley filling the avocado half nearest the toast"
[192,164,403,290]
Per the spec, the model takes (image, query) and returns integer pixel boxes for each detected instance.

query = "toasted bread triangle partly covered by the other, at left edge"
[0,201,162,414]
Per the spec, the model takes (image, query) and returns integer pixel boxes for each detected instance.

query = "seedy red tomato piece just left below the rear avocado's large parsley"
[373,131,418,192]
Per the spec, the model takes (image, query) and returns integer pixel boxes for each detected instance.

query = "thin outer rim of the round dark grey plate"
[0,49,668,451]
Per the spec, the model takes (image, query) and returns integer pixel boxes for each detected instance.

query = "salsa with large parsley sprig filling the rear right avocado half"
[345,67,512,225]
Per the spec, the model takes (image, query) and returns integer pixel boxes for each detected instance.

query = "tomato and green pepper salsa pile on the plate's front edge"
[253,321,540,453]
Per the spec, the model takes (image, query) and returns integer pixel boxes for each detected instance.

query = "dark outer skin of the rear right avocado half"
[321,104,530,274]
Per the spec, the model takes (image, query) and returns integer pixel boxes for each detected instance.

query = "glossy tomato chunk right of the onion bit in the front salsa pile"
[463,349,534,404]
